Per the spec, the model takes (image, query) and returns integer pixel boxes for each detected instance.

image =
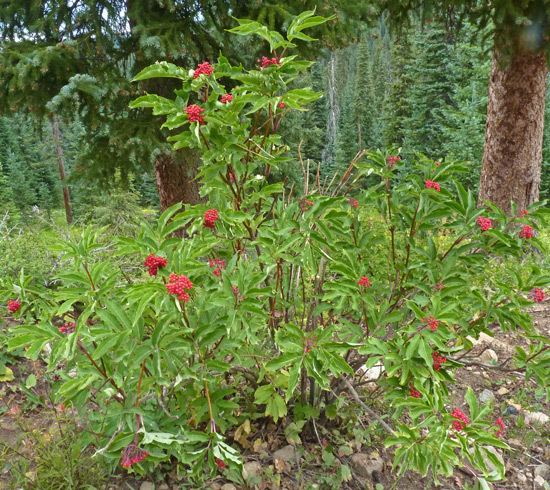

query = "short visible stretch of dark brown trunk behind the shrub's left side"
[155,150,201,211]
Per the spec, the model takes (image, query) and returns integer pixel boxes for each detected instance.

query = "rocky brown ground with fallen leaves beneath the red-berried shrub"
[0,300,550,490]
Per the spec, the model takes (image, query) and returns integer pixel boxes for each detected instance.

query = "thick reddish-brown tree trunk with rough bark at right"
[479,49,548,212]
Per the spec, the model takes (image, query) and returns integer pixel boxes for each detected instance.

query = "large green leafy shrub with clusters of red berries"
[2,12,548,482]
